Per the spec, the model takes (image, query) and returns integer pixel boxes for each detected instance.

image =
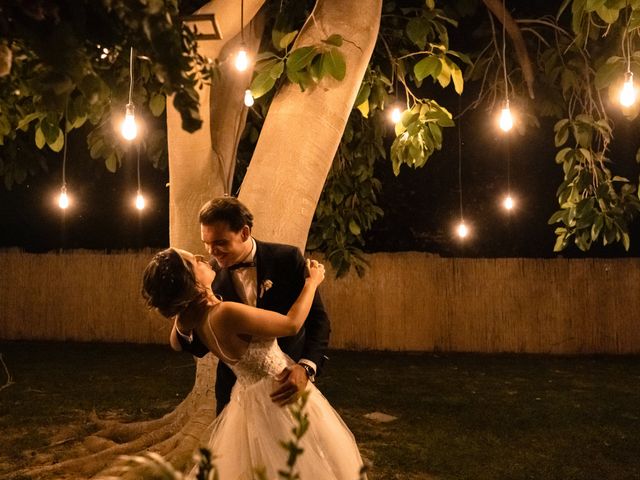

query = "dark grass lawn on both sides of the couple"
[0,342,640,480]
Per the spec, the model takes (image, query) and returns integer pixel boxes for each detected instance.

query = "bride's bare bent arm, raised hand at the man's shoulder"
[218,260,324,337]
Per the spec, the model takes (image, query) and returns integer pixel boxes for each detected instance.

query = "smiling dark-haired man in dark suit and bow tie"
[172,197,330,414]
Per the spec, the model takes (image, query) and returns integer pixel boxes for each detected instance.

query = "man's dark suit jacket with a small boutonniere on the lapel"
[179,240,331,413]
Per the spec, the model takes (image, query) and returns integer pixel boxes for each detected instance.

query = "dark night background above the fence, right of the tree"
[368,100,640,257]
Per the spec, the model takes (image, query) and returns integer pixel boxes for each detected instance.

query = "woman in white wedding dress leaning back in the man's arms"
[142,248,362,480]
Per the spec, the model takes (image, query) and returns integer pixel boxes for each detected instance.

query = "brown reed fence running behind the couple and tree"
[0,250,640,354]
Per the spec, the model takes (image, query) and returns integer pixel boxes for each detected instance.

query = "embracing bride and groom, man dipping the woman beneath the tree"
[143,197,362,480]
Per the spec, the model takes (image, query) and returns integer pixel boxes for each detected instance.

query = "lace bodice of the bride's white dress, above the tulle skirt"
[227,338,290,385]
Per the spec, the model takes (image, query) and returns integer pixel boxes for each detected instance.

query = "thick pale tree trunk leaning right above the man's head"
[240,0,382,249]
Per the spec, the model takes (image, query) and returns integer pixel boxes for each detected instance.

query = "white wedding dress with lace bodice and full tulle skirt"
[200,338,362,480]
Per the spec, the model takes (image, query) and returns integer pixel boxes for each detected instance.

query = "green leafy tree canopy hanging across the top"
[0,0,640,274]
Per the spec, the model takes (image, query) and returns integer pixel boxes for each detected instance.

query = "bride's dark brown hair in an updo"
[142,248,203,318]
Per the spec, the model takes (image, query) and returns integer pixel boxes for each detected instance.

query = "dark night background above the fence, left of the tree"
[0,146,169,252]
